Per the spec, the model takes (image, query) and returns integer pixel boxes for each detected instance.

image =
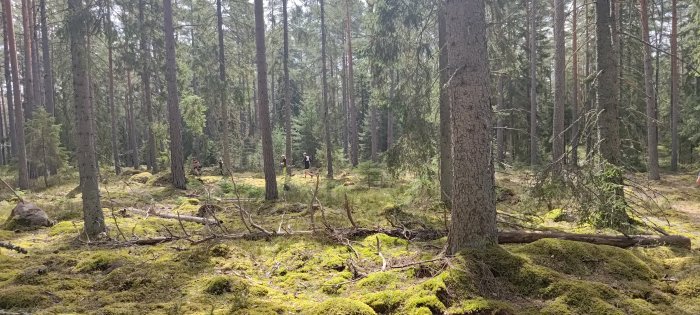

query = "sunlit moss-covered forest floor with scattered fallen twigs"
[0,169,700,315]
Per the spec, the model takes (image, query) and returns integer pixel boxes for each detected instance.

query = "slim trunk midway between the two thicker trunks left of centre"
[216,0,233,174]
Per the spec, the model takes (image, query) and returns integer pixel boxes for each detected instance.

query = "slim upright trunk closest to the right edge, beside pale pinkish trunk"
[671,0,681,172]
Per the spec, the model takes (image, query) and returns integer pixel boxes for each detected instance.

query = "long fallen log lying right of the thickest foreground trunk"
[498,231,690,249]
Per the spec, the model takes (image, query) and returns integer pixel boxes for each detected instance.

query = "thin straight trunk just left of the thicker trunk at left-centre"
[139,0,158,173]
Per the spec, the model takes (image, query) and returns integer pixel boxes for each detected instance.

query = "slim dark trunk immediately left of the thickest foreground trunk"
[438,1,452,205]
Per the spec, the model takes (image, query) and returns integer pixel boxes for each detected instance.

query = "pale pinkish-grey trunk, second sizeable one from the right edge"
[639,0,661,180]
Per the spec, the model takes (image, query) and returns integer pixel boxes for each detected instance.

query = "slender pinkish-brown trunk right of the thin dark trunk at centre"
[345,0,360,166]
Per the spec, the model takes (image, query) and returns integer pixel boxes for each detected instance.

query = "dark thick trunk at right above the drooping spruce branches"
[596,0,621,165]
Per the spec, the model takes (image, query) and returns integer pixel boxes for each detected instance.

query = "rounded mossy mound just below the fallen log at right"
[514,239,656,280]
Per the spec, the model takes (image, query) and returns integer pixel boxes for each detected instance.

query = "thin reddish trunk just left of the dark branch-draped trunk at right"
[571,0,588,167]
